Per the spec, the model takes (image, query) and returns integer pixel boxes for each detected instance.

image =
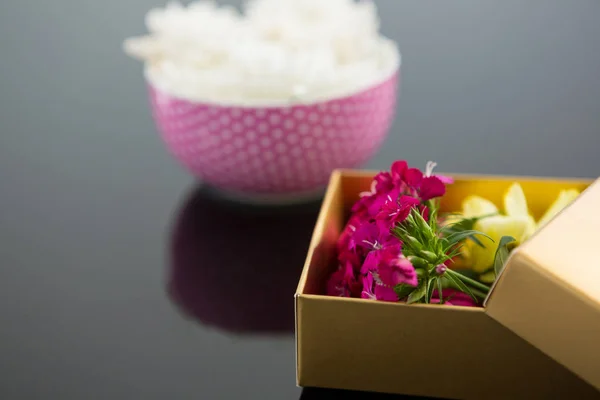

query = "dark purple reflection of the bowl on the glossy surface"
[167,187,319,334]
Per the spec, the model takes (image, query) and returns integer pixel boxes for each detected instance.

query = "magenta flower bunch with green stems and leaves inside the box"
[327,161,516,306]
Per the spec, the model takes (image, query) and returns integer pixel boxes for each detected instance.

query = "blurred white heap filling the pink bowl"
[124,0,400,106]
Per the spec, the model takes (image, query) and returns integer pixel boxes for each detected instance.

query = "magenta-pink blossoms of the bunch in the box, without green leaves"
[327,161,460,304]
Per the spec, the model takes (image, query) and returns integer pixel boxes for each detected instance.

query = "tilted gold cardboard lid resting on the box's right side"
[485,179,600,389]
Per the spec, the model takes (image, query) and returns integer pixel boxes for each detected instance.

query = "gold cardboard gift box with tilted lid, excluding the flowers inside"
[295,170,600,399]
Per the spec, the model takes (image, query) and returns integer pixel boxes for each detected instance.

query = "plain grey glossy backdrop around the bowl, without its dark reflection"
[0,0,600,399]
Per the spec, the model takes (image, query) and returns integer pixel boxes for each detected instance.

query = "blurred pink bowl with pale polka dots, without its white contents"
[149,72,399,203]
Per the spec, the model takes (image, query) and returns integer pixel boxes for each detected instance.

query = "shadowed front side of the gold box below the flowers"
[298,295,600,400]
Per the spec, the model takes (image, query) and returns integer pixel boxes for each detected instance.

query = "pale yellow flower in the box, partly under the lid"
[449,183,579,273]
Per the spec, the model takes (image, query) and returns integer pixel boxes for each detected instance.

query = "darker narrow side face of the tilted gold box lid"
[486,251,600,389]
